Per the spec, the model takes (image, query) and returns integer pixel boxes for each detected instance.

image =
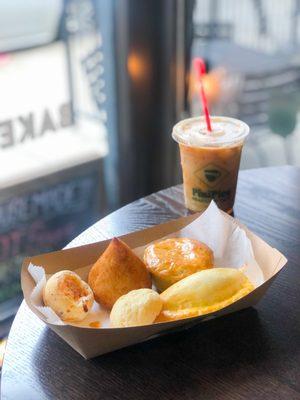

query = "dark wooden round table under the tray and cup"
[1,167,300,400]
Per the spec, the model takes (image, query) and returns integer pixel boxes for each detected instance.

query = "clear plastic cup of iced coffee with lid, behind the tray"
[172,117,249,213]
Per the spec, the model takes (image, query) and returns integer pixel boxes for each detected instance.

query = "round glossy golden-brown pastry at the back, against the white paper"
[144,238,214,292]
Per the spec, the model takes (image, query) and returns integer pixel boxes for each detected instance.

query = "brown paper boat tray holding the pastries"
[21,214,287,359]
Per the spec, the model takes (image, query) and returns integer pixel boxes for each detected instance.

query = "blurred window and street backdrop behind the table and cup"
[0,0,300,362]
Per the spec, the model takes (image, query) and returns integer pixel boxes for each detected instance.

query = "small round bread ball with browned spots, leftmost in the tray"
[43,271,94,322]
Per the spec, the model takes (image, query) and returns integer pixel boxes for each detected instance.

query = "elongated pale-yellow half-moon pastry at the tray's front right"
[157,268,254,322]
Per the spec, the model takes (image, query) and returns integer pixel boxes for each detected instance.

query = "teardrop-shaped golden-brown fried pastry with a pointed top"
[88,238,151,309]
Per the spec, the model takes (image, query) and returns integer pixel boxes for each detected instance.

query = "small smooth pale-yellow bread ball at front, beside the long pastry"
[110,289,163,327]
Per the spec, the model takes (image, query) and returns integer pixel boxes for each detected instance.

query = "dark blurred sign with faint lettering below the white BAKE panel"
[0,160,103,320]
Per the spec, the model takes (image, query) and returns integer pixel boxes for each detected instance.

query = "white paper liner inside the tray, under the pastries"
[28,201,264,328]
